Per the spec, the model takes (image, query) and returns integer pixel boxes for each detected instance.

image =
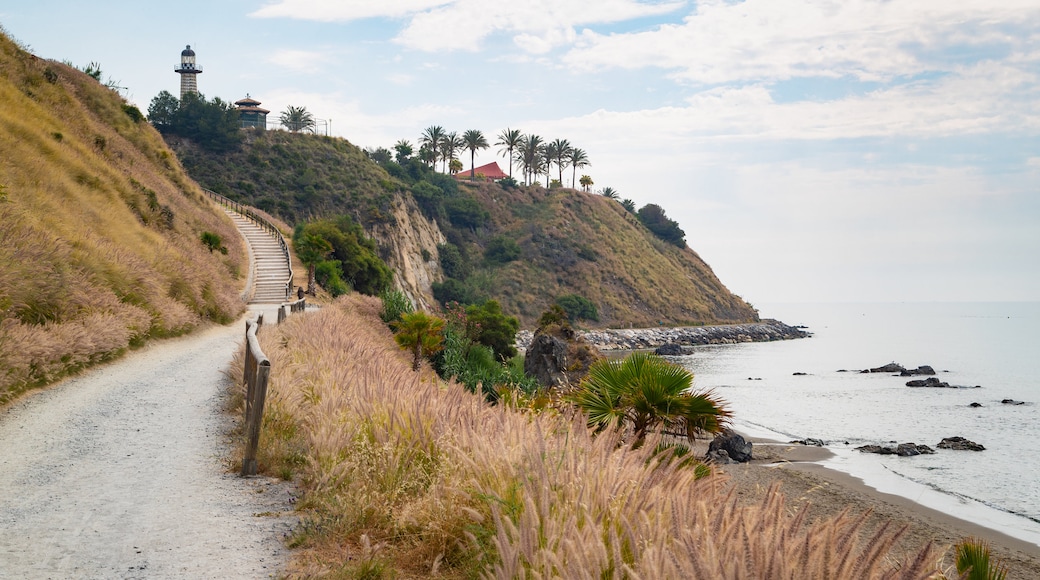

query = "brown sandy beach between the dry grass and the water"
[700,438,1040,580]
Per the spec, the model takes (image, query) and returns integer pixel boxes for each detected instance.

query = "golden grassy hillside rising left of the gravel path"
[0,33,246,404]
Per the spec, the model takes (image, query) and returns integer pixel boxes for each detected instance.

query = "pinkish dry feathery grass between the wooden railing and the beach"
[245,295,938,579]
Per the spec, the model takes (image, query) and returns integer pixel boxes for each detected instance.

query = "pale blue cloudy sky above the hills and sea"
[0,0,1040,307]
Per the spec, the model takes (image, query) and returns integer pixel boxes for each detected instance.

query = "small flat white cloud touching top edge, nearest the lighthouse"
[250,0,451,22]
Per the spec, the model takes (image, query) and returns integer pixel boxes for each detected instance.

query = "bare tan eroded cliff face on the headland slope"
[366,195,446,311]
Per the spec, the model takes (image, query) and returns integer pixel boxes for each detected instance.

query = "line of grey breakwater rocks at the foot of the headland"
[517,319,812,353]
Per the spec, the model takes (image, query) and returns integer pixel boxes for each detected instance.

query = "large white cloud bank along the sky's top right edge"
[564,0,1040,84]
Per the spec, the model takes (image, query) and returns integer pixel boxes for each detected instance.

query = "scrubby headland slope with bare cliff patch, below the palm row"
[170,131,757,327]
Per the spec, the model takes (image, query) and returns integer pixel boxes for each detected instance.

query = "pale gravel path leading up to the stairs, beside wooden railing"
[0,323,293,579]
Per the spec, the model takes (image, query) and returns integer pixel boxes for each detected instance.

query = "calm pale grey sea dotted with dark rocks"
[680,302,1040,546]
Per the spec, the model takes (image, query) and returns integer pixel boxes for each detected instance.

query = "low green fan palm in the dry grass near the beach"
[570,352,731,447]
